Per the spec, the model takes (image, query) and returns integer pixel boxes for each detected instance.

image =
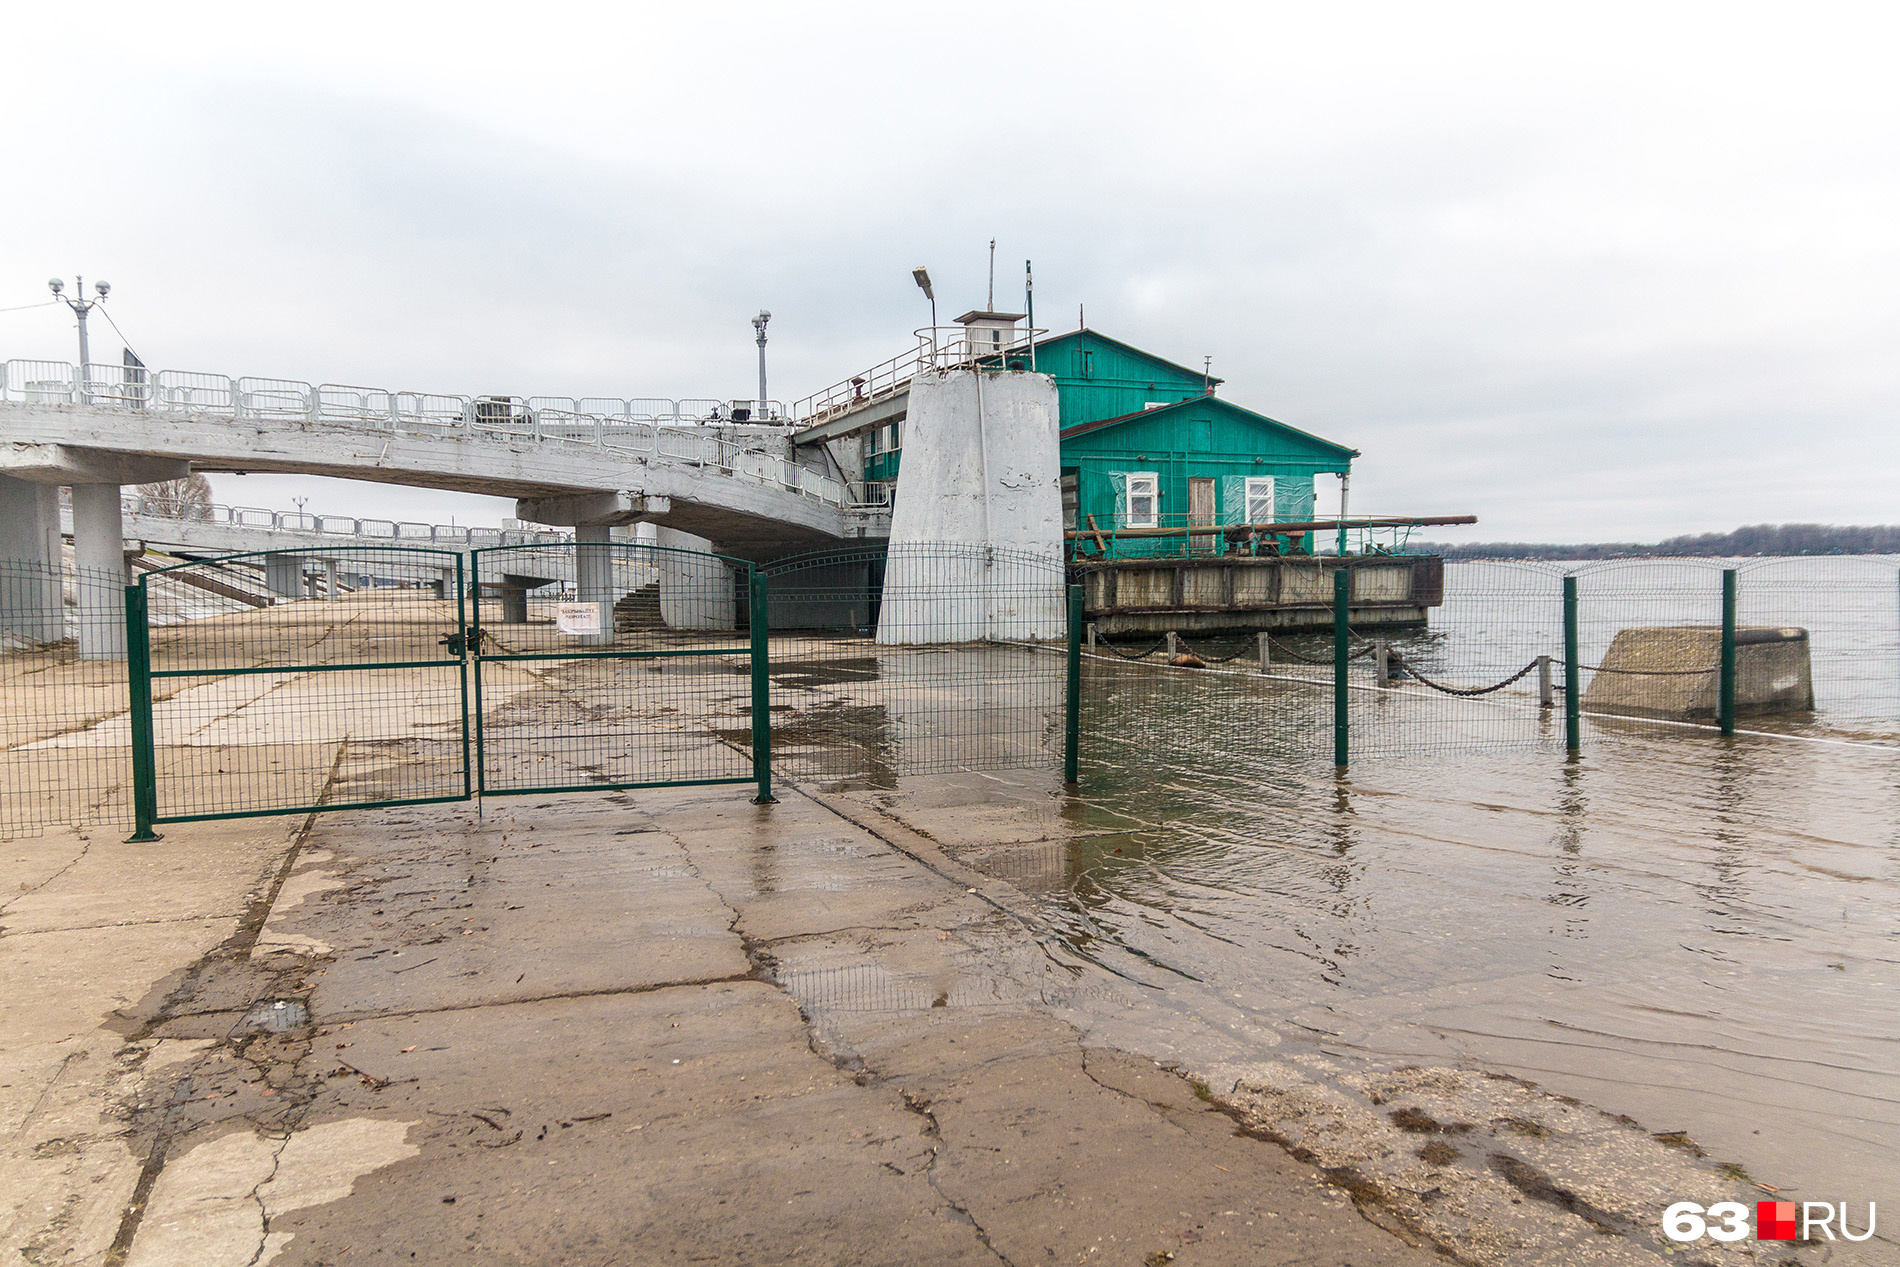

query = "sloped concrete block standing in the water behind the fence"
[1583,625,1815,722]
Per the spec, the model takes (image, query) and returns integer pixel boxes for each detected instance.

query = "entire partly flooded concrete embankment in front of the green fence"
[0,638,1900,1267]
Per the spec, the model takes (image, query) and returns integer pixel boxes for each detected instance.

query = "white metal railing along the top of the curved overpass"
[0,359,846,507]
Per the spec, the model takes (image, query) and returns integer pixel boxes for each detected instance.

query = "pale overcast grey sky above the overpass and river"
[0,2,1900,541]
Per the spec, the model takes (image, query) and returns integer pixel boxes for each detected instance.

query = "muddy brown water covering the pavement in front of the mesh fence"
[1041,721,1900,1201]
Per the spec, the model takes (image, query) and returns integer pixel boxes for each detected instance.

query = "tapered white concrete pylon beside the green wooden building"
[878,369,1068,646]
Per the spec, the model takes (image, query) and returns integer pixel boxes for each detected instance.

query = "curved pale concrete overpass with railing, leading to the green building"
[0,361,889,655]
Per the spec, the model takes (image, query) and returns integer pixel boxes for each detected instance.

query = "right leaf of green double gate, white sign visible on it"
[469,541,771,802]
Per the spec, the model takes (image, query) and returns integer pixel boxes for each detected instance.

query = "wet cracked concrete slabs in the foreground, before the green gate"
[66,790,1436,1267]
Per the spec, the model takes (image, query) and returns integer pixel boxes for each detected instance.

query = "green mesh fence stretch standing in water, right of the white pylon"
[1083,557,1900,766]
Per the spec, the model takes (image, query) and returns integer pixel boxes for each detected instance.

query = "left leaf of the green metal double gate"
[125,547,471,840]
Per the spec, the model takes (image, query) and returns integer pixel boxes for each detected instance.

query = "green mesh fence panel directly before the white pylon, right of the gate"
[766,545,1066,785]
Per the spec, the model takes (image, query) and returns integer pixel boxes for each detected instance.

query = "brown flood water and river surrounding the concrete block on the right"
[973,560,1900,1201]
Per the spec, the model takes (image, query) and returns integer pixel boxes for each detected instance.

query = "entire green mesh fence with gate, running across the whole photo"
[0,543,1900,836]
